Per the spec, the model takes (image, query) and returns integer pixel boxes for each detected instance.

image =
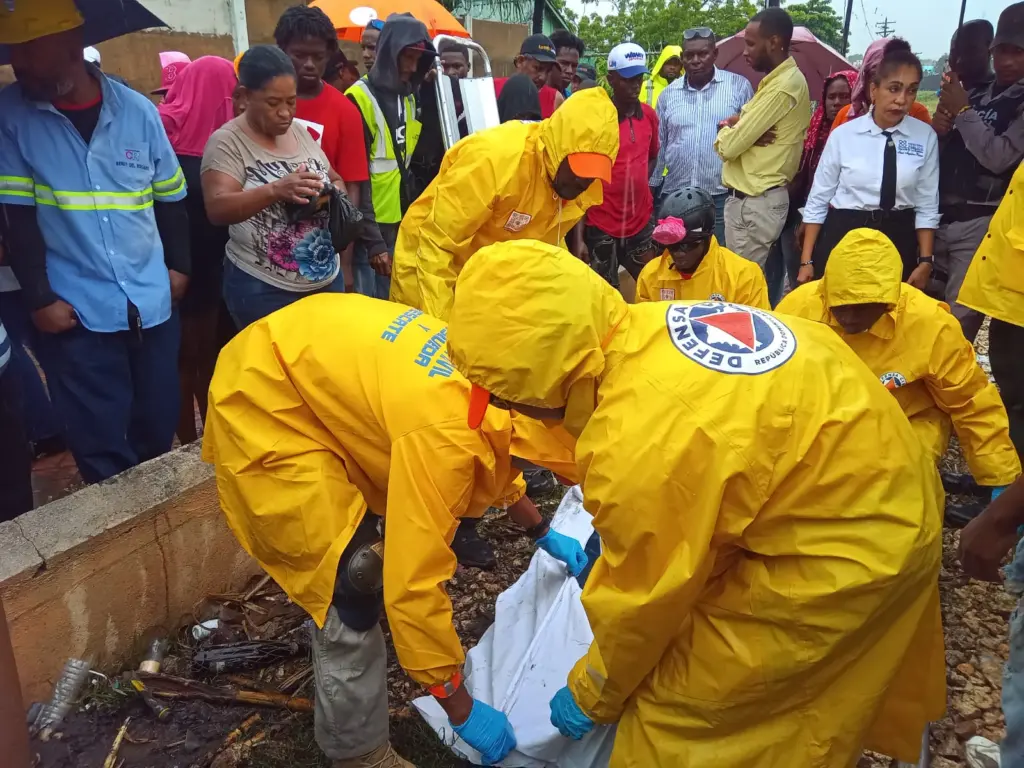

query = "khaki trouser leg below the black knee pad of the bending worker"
[312,605,388,760]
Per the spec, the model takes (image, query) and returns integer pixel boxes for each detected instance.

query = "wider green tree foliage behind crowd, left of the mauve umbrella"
[579,0,758,54]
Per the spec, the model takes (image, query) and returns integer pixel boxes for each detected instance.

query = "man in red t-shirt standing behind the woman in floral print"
[273,5,387,280]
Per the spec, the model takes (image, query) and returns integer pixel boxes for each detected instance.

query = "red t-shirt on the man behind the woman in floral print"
[295,83,370,181]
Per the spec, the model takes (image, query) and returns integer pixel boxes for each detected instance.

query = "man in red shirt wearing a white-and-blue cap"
[581,43,658,288]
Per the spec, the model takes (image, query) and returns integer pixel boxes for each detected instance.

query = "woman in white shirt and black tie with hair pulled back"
[797,50,939,289]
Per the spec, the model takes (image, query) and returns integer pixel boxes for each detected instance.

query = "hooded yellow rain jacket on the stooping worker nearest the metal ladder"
[391,88,618,319]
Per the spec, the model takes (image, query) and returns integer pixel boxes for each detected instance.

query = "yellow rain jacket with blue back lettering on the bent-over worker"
[203,294,571,685]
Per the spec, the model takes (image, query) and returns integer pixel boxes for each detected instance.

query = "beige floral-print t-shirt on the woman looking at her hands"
[202,116,340,292]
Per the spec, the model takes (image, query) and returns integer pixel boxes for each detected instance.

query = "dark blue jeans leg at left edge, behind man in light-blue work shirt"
[0,291,63,442]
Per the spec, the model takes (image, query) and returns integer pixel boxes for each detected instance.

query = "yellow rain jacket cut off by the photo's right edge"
[956,164,1024,326]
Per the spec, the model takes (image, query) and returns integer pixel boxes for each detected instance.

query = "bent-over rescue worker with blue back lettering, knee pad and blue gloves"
[203,294,587,768]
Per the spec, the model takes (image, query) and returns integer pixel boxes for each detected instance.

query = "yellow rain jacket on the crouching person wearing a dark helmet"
[636,237,771,309]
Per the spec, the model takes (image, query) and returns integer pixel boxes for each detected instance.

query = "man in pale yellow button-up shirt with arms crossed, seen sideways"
[715,8,811,269]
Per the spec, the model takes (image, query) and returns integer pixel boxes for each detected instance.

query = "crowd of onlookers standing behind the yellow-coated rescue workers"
[0,3,1024,528]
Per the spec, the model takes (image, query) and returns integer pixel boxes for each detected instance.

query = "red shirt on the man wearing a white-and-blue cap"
[587,103,658,238]
